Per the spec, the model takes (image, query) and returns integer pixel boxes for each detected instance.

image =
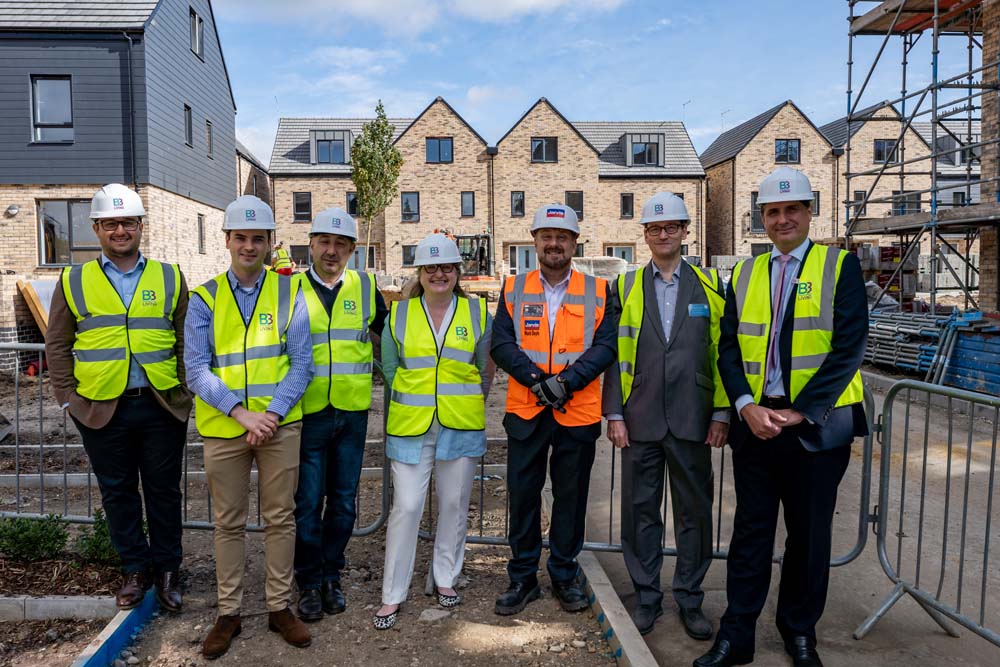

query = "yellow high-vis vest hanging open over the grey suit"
[618,266,729,409]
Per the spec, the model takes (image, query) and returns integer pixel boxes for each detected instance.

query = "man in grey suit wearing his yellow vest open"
[603,192,729,640]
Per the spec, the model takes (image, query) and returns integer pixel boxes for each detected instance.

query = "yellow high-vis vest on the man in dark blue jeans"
[296,269,376,415]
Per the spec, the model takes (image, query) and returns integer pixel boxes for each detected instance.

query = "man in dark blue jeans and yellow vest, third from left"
[295,208,388,621]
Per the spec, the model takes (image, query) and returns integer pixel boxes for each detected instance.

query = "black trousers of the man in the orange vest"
[504,409,601,582]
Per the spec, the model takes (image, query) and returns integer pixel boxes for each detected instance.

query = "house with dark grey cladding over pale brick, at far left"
[0,0,237,362]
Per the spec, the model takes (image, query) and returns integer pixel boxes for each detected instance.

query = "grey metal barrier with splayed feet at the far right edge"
[854,380,1000,646]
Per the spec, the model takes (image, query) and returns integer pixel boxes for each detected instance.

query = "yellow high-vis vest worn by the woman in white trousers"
[386,296,486,436]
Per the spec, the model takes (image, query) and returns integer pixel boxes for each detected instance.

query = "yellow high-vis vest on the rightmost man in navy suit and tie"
[732,244,864,407]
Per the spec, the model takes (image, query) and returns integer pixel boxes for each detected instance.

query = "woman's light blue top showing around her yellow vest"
[382,298,493,465]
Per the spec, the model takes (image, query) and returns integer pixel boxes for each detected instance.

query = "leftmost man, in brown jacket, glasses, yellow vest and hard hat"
[45,183,191,612]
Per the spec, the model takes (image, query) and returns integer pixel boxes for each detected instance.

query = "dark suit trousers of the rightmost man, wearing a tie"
[719,432,851,654]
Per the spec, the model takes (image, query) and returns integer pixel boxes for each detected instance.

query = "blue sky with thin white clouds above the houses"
[213,0,978,161]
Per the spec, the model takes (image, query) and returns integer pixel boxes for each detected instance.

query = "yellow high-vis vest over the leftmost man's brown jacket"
[62,259,180,401]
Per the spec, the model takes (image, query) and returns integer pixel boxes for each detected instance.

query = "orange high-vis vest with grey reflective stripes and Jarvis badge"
[504,269,607,426]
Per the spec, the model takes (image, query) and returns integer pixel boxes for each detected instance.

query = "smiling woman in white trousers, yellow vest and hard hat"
[373,234,495,630]
